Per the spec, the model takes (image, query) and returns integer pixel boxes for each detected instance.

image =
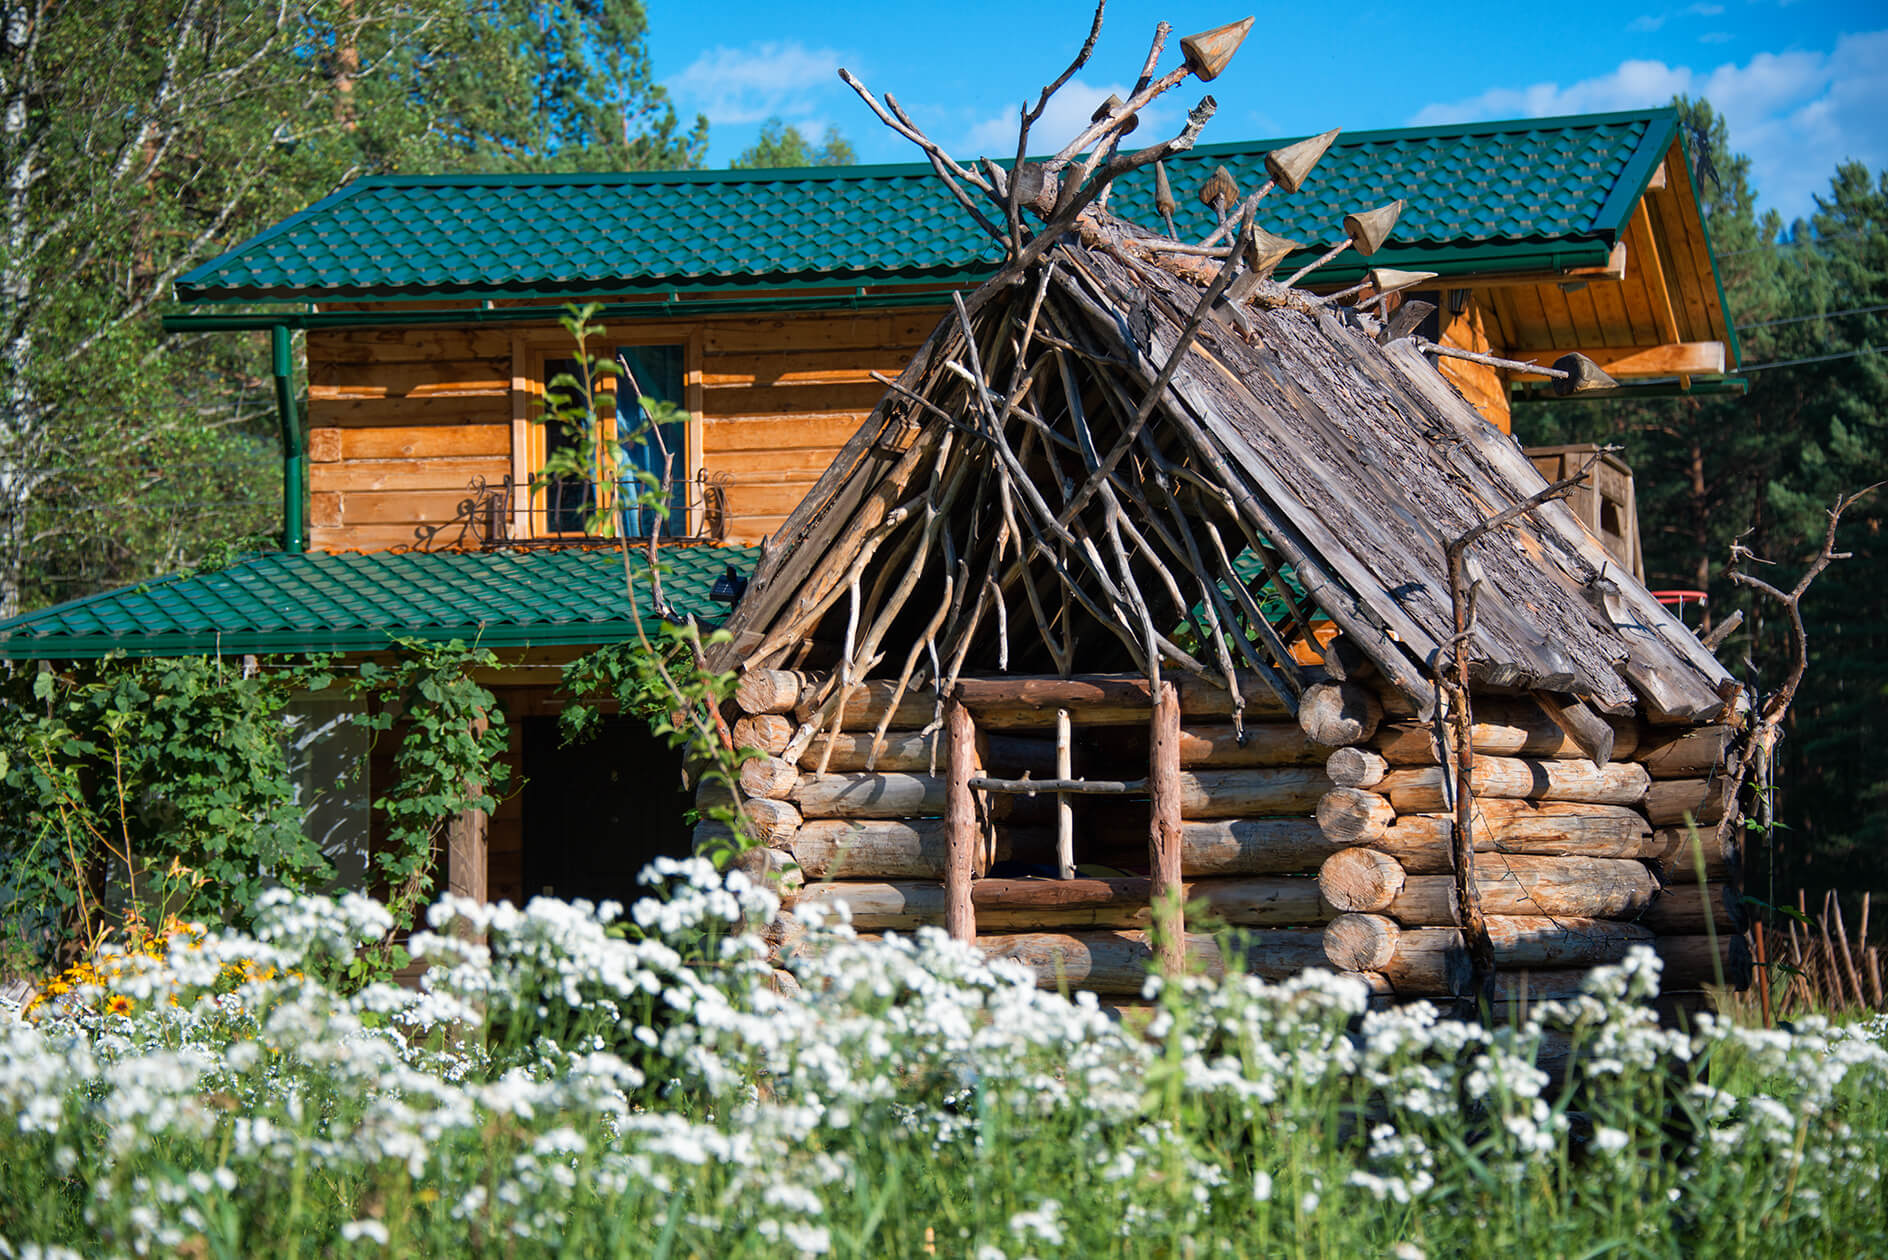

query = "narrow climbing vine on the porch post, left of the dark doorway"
[355,639,510,975]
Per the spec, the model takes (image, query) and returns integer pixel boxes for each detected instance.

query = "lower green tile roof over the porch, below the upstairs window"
[0,546,759,661]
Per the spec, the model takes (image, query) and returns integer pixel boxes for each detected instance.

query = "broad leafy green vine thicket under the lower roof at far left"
[0,657,329,962]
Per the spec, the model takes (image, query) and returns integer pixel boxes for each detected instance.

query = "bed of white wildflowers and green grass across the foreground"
[0,861,1888,1260]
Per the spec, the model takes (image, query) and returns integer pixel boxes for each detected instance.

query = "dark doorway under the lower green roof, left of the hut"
[521,718,693,905]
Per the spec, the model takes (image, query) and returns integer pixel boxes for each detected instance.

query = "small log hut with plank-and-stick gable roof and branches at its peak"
[710,11,1746,999]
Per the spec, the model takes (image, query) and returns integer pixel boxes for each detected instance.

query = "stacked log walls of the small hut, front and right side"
[713,671,1748,1003]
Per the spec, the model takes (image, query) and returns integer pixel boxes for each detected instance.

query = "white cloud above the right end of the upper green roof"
[1410,30,1888,217]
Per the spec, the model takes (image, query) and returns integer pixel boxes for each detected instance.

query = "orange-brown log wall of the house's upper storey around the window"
[308,308,938,552]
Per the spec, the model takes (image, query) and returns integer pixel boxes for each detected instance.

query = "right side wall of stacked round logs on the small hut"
[1318,697,1750,999]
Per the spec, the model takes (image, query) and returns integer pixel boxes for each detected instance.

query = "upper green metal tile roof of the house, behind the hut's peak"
[176,110,1677,302]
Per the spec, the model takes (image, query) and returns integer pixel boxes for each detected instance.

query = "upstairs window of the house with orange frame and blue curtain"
[529,346,689,538]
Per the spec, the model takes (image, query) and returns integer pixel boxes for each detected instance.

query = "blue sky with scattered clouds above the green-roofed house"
[648,0,1888,219]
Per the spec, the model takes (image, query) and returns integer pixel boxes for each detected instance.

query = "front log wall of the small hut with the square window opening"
[709,671,1359,996]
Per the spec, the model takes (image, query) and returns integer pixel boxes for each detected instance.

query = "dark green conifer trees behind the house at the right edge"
[1514,100,1888,903]
